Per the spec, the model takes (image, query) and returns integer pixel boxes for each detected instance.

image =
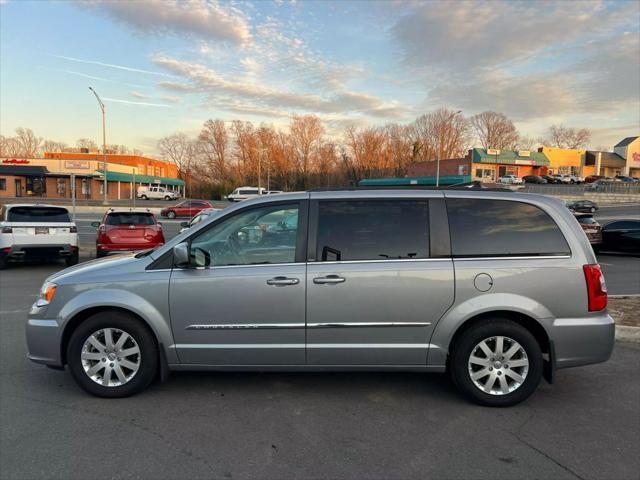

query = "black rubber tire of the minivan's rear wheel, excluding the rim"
[449,319,543,407]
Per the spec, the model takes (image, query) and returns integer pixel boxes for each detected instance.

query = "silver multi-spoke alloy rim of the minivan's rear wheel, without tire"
[468,336,529,395]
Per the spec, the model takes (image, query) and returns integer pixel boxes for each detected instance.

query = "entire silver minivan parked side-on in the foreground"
[27,190,614,406]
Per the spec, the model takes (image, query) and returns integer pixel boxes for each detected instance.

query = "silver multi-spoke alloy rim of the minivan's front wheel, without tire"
[80,328,141,387]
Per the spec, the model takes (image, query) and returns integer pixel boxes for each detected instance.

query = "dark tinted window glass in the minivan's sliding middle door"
[316,200,429,262]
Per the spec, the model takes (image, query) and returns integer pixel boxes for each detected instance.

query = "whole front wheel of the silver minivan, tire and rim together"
[67,311,158,398]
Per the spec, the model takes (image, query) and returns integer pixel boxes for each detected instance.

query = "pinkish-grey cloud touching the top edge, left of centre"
[81,0,251,45]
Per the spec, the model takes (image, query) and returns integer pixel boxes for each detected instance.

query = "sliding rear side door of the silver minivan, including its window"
[307,192,454,365]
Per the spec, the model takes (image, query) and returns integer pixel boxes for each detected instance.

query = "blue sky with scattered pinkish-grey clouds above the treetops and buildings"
[0,0,640,154]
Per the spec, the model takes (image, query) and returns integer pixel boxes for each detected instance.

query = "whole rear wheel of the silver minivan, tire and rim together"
[449,319,543,407]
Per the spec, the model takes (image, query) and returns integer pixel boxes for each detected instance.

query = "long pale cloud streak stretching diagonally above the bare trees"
[154,55,407,117]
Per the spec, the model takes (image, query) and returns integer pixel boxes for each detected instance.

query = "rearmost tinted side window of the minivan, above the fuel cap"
[447,198,570,257]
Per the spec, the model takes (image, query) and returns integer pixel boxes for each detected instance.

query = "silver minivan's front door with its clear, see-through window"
[169,201,306,365]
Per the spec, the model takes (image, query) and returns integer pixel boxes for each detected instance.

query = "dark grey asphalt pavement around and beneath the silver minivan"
[0,258,640,479]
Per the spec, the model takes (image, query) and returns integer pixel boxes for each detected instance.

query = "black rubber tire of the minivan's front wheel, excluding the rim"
[67,310,158,398]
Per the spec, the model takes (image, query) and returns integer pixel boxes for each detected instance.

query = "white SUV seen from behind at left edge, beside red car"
[0,204,78,268]
